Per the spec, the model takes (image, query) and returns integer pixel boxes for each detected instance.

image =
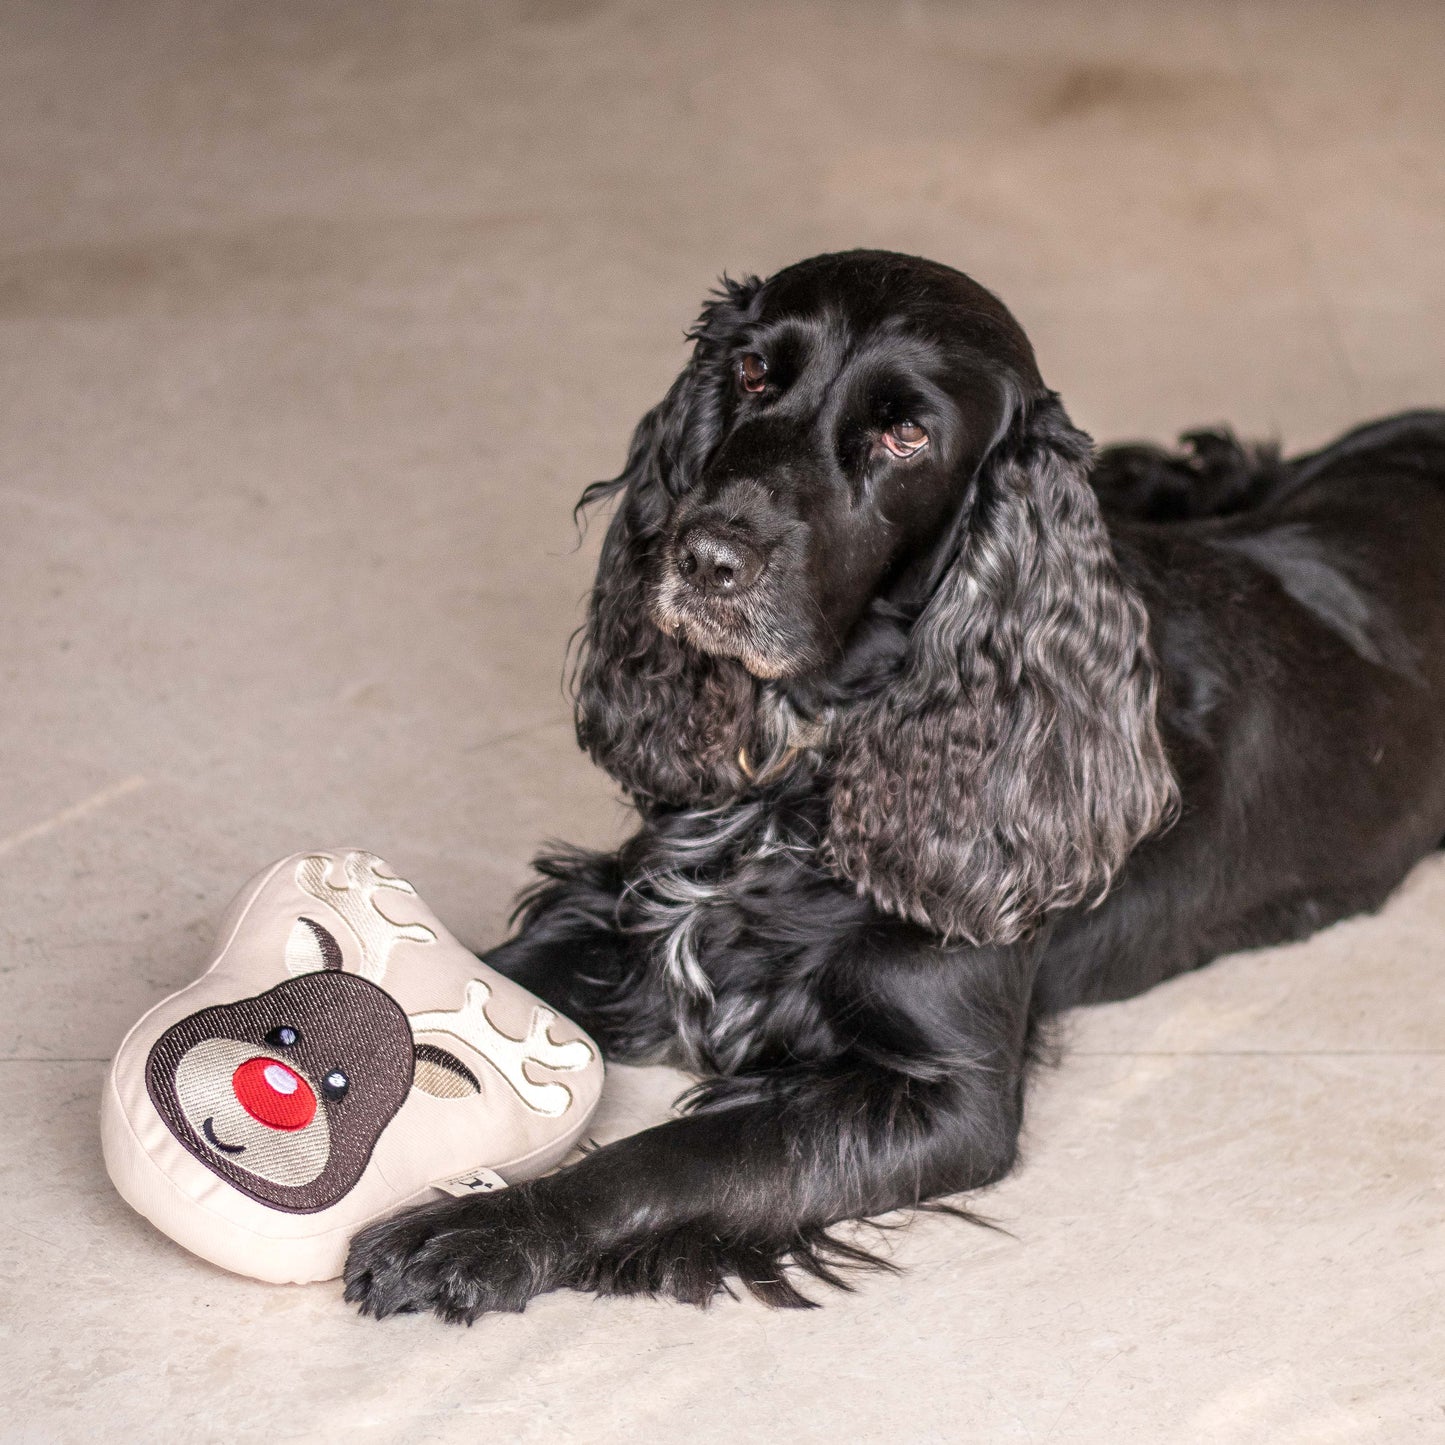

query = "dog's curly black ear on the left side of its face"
[574,279,760,808]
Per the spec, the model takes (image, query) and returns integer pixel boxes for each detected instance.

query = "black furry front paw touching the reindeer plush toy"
[344,1189,551,1325]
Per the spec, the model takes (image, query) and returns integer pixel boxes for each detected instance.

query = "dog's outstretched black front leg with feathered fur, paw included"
[345,946,1033,1321]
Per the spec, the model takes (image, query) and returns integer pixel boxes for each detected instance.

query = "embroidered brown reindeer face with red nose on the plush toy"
[146,920,477,1214]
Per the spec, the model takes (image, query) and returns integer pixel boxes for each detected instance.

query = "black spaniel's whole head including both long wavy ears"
[578,251,1173,939]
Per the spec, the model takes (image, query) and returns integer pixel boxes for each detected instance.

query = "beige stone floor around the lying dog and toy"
[0,0,1445,1445]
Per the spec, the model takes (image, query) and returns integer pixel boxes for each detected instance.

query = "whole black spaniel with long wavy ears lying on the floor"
[345,251,1445,1322]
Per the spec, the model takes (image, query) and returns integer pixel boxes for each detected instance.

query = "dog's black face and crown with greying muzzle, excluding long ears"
[650,253,1042,678]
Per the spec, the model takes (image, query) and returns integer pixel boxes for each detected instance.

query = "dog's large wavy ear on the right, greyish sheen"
[828,396,1176,944]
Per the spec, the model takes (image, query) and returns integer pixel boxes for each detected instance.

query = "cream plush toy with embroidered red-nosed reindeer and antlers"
[101,850,603,1282]
